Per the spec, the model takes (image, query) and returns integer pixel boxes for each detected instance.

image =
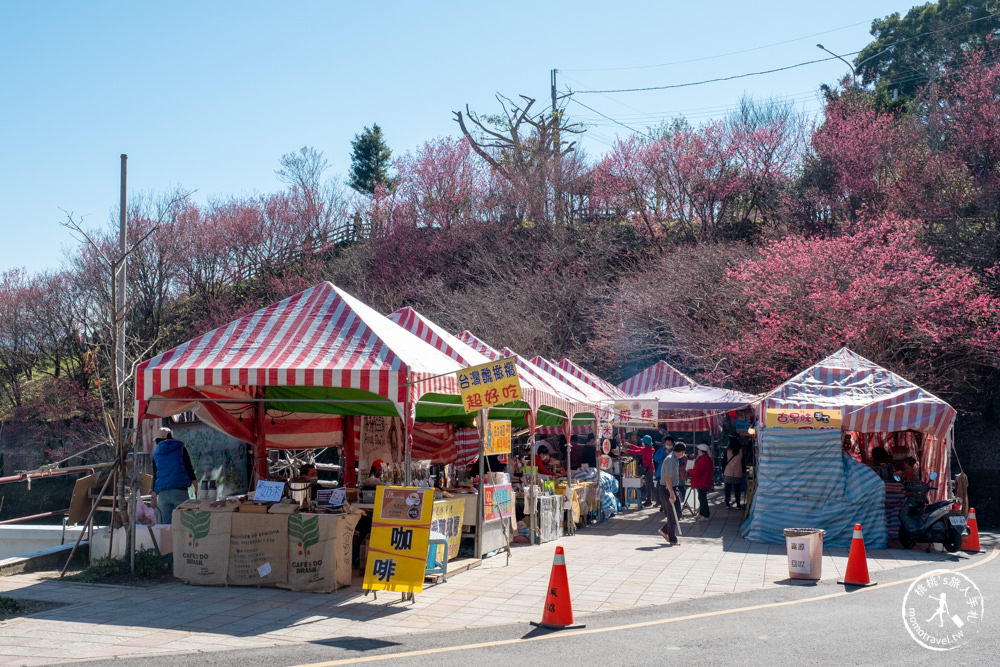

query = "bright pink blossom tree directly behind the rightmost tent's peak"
[718,215,1000,396]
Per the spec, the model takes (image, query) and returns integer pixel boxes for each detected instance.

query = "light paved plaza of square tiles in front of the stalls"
[0,498,987,665]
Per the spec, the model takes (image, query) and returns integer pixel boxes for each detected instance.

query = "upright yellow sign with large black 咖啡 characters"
[364,486,434,593]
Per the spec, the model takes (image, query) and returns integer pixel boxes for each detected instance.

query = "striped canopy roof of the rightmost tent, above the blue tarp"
[758,347,956,497]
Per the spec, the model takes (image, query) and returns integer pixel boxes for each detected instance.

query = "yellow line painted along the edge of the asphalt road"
[296,548,1000,667]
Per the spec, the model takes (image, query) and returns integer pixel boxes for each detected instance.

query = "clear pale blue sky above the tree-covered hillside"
[0,0,911,271]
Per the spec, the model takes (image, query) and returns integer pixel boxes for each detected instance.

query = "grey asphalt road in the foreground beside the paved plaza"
[74,552,1000,667]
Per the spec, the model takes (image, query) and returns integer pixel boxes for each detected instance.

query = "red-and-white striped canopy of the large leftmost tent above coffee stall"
[135,283,471,468]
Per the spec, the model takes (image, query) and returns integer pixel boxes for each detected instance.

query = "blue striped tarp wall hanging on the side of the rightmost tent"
[740,428,888,548]
